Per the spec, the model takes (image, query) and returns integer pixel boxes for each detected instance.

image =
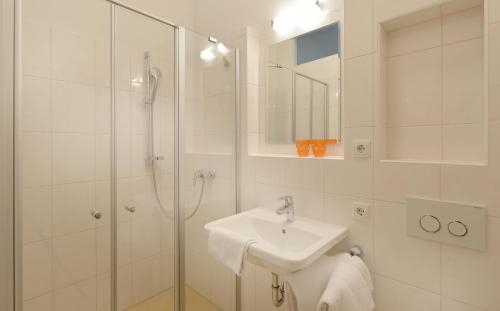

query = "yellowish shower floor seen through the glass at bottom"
[127,286,221,311]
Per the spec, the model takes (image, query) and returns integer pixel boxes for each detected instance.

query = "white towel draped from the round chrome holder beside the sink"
[316,257,375,311]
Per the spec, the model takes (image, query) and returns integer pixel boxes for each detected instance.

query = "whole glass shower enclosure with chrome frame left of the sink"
[16,0,239,311]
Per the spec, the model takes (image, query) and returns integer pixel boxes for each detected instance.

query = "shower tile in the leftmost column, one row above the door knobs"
[22,132,52,187]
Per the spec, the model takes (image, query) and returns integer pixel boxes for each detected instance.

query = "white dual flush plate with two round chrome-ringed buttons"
[406,198,486,251]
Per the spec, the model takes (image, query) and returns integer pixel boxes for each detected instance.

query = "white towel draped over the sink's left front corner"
[208,228,255,276]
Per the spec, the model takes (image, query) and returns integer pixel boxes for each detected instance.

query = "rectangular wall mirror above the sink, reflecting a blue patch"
[265,22,341,144]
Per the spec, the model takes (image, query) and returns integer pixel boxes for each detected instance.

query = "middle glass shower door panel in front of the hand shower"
[114,6,176,311]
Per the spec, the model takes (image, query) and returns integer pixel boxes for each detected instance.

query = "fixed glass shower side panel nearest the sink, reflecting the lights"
[179,31,237,311]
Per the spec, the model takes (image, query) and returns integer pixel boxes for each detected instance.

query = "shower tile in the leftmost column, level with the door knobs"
[22,187,52,243]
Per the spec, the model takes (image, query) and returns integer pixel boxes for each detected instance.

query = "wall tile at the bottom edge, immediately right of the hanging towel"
[375,276,441,311]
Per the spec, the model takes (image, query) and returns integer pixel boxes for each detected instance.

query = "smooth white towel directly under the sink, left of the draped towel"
[285,254,350,311]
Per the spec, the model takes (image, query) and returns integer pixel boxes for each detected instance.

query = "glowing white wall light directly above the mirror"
[271,0,325,35]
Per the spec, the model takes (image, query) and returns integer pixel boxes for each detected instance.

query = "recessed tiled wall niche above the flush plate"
[377,0,487,165]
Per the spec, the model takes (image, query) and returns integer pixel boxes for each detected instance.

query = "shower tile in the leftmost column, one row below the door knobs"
[23,240,52,299]
